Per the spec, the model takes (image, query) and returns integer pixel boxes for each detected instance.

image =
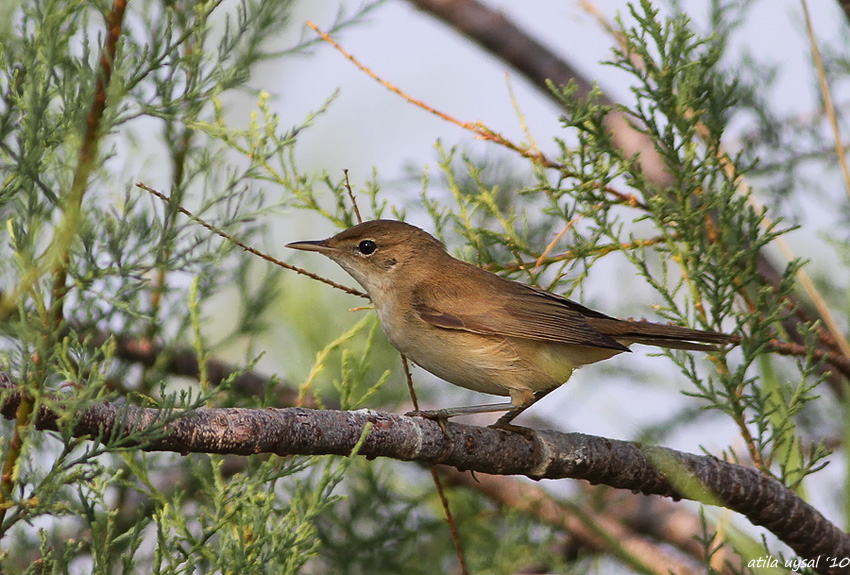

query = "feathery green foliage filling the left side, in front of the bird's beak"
[0,0,384,573]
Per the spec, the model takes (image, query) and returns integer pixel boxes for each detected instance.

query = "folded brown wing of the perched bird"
[413,272,629,351]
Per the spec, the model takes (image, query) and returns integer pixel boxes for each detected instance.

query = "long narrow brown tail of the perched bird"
[587,318,739,351]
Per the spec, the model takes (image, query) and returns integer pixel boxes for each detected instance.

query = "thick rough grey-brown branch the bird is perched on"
[0,379,850,575]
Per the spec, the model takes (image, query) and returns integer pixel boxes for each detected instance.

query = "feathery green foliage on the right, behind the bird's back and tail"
[414,1,832,568]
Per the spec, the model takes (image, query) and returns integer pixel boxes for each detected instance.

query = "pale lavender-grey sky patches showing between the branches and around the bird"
[215,0,846,515]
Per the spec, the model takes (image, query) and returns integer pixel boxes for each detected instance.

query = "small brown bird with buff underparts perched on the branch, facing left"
[287,220,735,426]
